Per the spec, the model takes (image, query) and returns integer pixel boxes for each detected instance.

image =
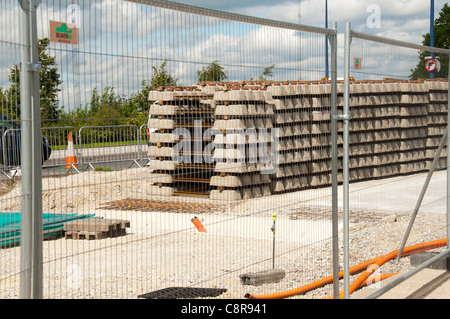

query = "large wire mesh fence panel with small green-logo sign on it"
[0,0,344,298]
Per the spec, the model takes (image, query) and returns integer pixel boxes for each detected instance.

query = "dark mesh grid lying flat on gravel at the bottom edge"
[138,287,227,299]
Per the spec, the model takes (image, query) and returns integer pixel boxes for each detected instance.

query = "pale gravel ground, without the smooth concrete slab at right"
[0,168,446,299]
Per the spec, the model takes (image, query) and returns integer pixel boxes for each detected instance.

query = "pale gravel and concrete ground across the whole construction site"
[1,168,450,299]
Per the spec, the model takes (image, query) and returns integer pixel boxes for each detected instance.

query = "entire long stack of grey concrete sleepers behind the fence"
[148,80,448,201]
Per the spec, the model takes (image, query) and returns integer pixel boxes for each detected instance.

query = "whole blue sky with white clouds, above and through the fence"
[0,0,447,109]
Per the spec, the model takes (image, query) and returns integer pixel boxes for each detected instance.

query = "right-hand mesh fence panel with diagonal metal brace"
[340,24,450,298]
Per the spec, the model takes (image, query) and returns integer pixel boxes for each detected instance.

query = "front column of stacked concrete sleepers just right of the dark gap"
[210,85,274,200]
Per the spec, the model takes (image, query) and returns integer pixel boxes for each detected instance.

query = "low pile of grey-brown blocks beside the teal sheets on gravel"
[63,218,130,240]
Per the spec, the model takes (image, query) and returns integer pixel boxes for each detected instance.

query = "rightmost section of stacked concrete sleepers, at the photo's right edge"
[425,80,448,169]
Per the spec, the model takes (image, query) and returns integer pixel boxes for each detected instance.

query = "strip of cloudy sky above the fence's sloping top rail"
[171,0,448,44]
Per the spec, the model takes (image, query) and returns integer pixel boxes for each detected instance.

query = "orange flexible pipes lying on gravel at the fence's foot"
[245,238,447,299]
